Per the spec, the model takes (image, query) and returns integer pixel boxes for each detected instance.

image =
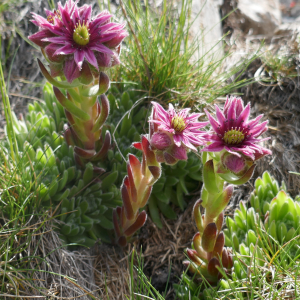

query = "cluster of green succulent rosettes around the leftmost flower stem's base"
[9,84,121,247]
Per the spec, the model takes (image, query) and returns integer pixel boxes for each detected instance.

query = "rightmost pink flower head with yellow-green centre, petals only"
[202,97,272,161]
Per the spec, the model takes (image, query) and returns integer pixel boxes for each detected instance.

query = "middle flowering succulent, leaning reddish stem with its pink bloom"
[113,102,208,246]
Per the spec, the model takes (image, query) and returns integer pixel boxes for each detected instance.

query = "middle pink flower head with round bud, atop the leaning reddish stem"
[149,102,209,164]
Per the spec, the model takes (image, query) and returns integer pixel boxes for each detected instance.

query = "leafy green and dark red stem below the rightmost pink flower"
[184,152,233,284]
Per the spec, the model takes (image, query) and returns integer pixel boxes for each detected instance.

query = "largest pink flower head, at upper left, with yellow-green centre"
[29,0,128,82]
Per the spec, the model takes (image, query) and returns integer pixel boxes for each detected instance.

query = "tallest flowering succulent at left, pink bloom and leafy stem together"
[29,0,127,172]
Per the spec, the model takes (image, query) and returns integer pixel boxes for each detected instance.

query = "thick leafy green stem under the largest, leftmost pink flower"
[48,72,111,167]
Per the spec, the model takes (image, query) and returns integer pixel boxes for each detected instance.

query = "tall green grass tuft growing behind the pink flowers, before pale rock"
[111,0,254,106]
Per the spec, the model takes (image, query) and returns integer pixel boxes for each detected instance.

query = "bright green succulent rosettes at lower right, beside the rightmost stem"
[219,171,300,299]
